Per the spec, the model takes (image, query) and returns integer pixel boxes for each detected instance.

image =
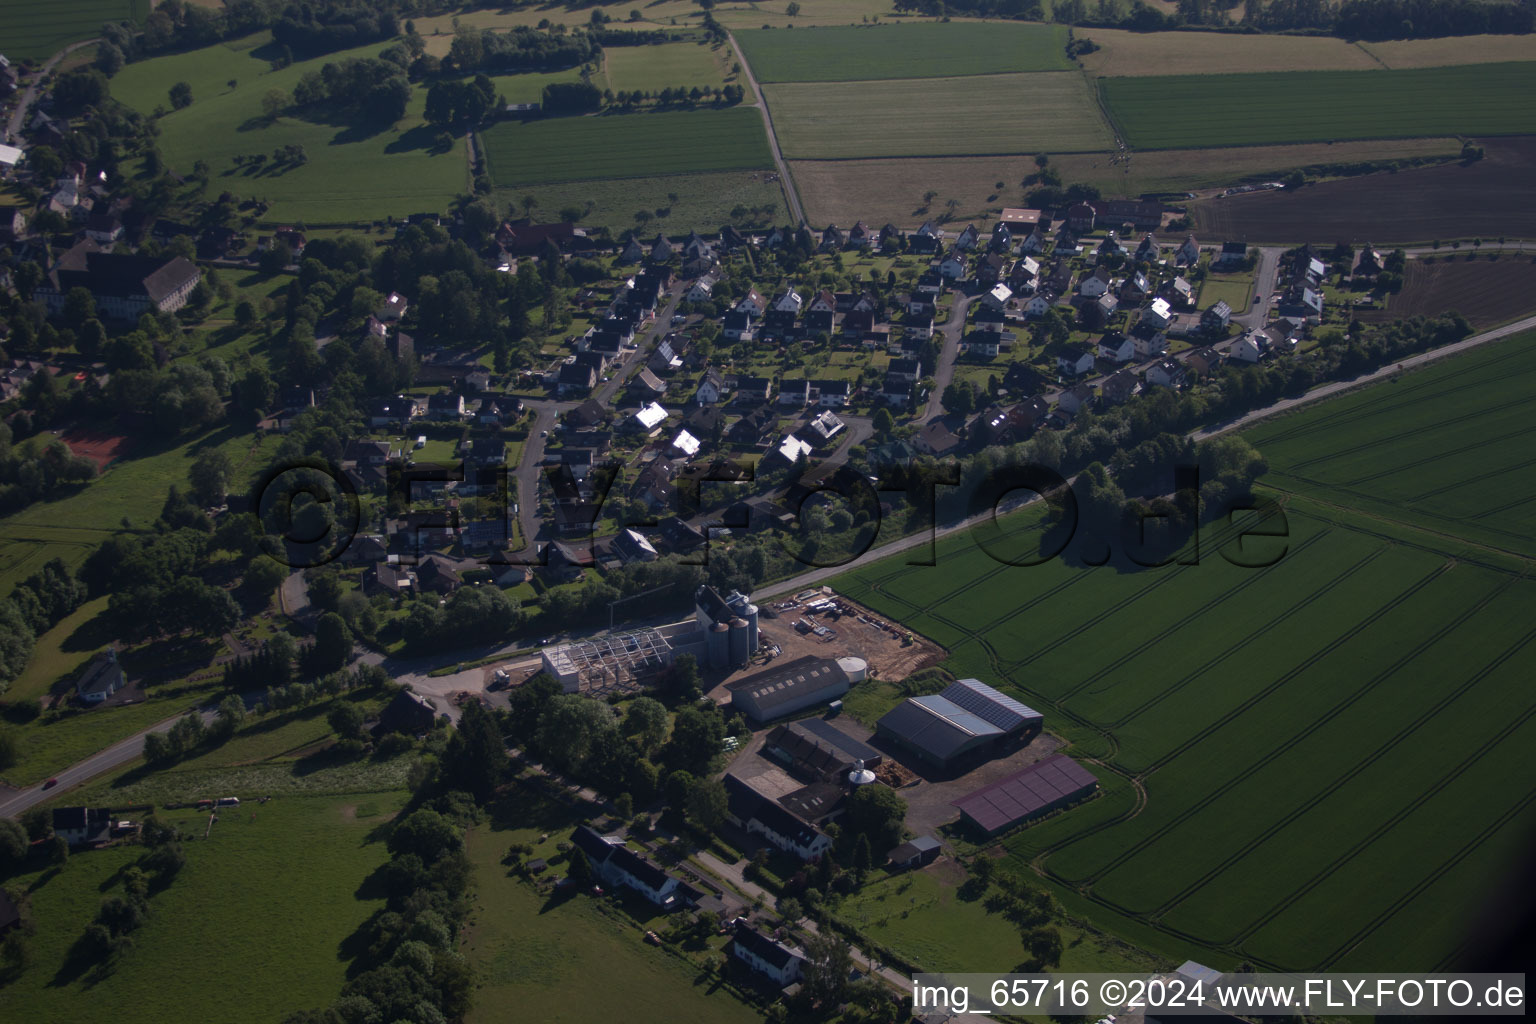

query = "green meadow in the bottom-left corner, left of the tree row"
[5,792,406,1024]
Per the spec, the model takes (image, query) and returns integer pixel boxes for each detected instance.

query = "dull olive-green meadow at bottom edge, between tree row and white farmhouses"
[462,795,760,1024]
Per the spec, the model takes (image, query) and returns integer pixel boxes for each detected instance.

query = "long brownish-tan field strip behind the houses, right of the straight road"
[790,137,1461,227]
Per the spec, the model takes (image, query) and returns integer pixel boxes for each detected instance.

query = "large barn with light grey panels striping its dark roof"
[876,679,1044,772]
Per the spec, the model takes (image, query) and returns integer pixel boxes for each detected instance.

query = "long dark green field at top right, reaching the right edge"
[1098,61,1536,149]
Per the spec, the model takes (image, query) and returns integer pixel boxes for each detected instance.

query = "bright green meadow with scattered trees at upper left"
[112,34,468,227]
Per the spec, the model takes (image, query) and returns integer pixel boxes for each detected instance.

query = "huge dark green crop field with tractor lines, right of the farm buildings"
[834,336,1536,970]
